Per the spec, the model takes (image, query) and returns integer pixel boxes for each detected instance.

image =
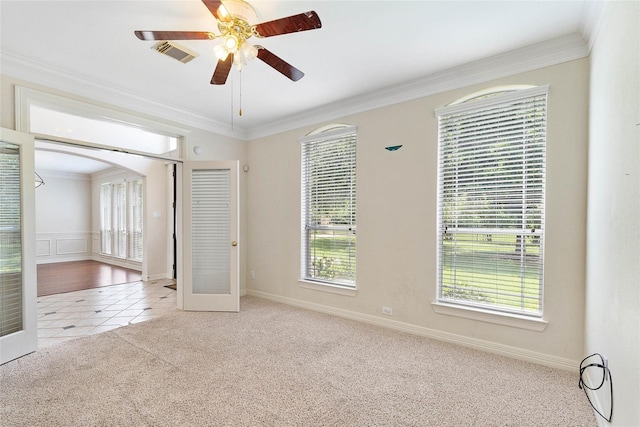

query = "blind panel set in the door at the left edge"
[0,142,23,336]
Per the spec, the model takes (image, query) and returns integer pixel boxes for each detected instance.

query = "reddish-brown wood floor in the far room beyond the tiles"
[38,260,141,297]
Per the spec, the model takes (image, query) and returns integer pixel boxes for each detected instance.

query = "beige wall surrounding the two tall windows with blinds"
[246,59,589,367]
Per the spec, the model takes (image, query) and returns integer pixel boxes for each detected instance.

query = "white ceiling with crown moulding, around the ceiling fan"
[0,0,601,172]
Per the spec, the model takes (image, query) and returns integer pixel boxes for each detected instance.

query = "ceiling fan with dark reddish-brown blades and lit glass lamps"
[135,0,322,85]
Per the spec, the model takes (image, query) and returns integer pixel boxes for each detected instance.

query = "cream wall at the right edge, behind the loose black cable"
[585,1,640,426]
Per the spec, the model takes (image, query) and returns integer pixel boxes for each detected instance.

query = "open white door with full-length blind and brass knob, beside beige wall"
[182,161,240,311]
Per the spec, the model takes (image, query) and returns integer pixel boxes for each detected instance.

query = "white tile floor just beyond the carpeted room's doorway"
[38,279,176,348]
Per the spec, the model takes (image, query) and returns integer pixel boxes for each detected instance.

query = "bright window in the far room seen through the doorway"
[100,178,144,262]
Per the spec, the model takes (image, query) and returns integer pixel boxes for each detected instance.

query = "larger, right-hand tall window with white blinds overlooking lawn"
[436,86,548,317]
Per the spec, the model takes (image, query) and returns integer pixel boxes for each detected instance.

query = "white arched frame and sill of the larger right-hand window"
[433,86,548,322]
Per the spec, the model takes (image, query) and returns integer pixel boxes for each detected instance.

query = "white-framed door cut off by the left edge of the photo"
[0,128,38,364]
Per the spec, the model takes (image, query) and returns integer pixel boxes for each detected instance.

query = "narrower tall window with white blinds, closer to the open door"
[300,126,356,288]
